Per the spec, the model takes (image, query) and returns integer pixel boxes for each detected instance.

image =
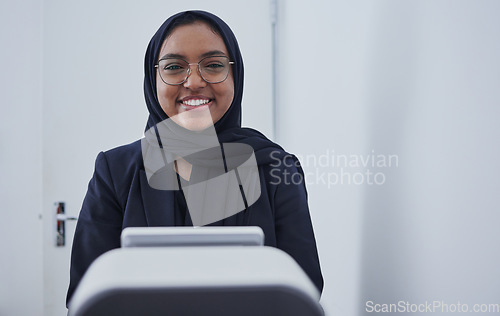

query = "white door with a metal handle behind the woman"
[42,0,272,316]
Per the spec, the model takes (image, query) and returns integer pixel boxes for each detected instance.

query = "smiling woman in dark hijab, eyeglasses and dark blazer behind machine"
[67,11,323,302]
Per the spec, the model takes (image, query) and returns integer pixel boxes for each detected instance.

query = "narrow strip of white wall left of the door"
[0,0,42,316]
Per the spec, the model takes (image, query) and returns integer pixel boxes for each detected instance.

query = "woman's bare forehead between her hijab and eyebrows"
[159,21,229,58]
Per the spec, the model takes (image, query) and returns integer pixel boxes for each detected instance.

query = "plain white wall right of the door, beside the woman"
[279,0,500,315]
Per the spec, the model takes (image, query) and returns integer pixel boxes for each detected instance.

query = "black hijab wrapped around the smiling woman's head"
[144,11,286,165]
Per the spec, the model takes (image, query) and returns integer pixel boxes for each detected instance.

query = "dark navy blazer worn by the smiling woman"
[67,141,323,303]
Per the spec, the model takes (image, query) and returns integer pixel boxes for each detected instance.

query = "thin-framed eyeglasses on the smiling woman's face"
[155,56,234,85]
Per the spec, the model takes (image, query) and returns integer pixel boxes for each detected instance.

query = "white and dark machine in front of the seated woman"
[68,227,324,316]
